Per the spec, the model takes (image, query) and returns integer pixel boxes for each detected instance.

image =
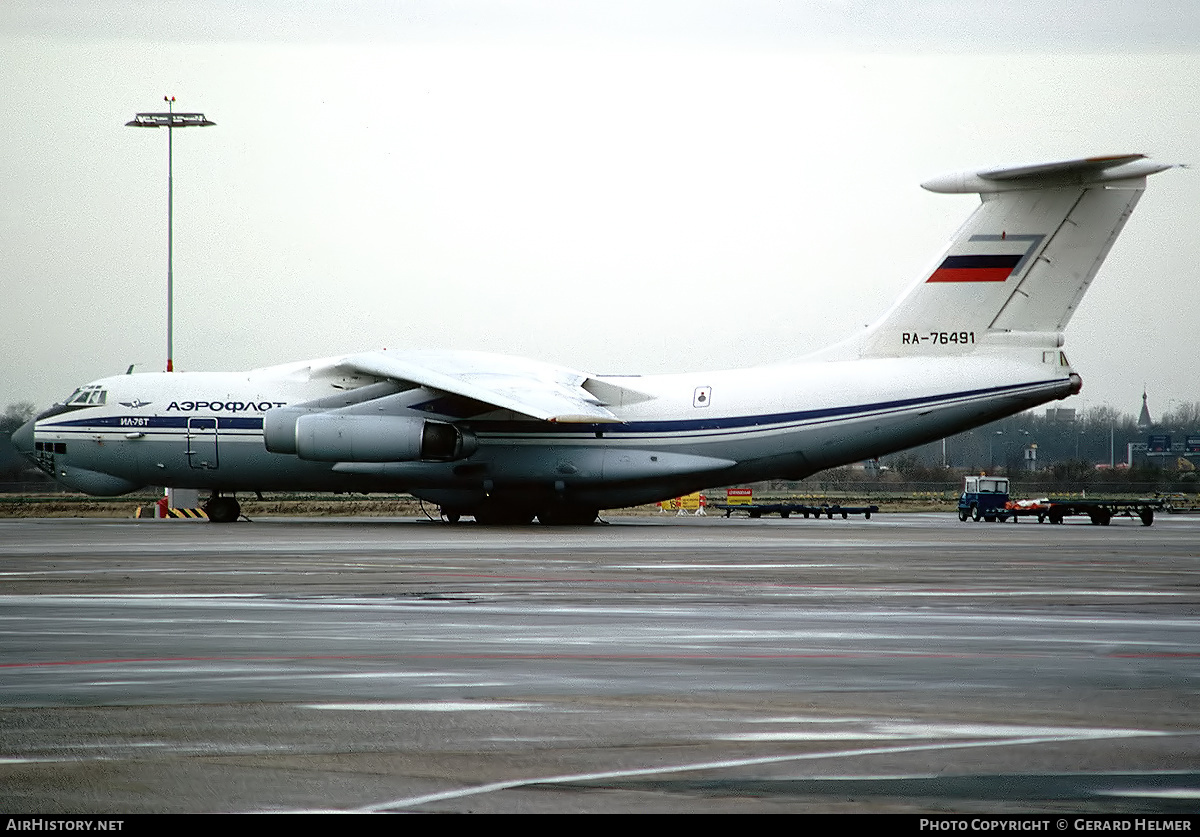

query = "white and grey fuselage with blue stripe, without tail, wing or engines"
[23,350,1079,508]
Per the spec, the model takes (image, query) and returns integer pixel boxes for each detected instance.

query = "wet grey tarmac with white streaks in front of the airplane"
[0,514,1200,814]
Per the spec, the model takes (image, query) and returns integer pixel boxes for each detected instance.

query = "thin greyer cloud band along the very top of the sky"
[4,0,1200,52]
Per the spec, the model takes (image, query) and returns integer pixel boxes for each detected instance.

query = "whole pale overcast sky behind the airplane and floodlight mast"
[0,0,1200,415]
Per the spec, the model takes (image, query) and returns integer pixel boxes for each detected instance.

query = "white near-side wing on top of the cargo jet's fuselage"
[340,351,628,423]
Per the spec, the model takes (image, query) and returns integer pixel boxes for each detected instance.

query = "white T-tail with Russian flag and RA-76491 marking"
[818,155,1171,357]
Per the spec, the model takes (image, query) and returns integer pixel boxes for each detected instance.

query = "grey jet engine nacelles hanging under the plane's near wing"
[270,408,479,462]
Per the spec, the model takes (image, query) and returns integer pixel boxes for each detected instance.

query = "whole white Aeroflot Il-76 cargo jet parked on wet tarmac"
[12,155,1172,525]
